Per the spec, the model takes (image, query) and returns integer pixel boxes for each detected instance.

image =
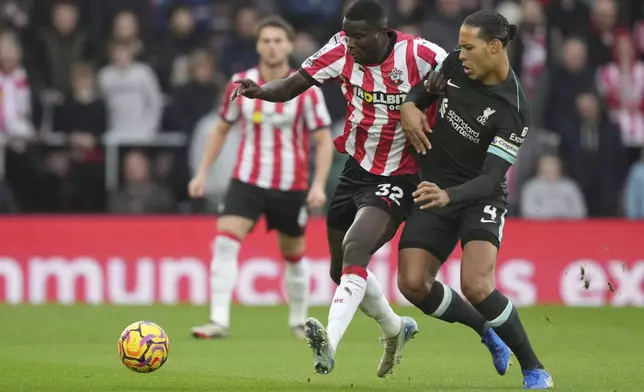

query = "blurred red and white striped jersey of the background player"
[220,68,331,191]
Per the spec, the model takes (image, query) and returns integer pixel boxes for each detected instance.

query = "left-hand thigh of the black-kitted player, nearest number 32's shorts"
[398,207,458,290]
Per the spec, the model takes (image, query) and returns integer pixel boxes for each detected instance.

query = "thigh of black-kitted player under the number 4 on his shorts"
[460,199,507,300]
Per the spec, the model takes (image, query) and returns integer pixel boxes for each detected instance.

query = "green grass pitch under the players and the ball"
[0,306,644,392]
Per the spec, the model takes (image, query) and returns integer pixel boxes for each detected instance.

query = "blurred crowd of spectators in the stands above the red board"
[0,0,644,219]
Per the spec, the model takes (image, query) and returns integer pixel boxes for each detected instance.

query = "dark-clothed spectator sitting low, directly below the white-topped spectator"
[110,151,173,214]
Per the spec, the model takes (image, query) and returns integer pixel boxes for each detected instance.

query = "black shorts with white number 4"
[398,198,507,263]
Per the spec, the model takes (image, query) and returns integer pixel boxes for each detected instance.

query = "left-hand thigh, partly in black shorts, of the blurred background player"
[217,180,265,239]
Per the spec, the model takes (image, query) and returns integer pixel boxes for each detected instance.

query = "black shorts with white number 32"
[327,157,419,231]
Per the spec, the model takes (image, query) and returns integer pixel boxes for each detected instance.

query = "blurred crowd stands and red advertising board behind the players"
[0,0,644,306]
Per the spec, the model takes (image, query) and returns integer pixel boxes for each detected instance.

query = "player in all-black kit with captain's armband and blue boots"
[398,10,553,389]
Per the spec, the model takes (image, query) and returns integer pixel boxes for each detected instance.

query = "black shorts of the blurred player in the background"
[220,180,308,237]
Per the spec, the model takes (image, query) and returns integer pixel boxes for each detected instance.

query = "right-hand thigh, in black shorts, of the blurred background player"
[265,190,308,238]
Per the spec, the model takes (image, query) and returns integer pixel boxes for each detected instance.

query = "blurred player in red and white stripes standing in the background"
[189,18,333,338]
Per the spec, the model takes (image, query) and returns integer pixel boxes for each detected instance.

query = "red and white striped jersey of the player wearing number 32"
[302,30,447,176]
